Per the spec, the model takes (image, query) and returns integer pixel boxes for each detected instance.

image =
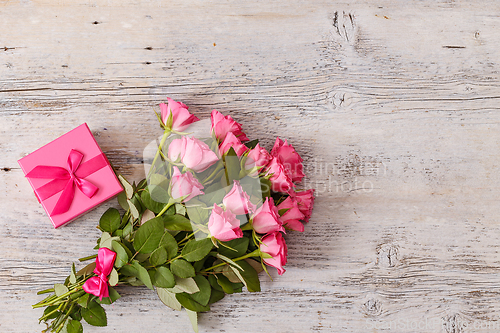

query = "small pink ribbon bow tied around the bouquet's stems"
[83,247,116,301]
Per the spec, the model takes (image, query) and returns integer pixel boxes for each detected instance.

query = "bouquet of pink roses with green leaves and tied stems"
[33,98,314,333]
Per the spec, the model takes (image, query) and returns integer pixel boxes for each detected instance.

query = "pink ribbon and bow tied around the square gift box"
[26,149,107,215]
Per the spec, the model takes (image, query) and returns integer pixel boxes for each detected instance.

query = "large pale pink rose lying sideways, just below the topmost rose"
[168,136,219,172]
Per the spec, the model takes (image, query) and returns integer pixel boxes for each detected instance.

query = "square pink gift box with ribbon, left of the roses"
[18,124,123,228]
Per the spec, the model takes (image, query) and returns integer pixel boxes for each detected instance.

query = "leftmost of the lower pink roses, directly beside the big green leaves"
[208,204,243,242]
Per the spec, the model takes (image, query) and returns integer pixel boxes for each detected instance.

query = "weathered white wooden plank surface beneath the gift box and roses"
[0,0,500,333]
